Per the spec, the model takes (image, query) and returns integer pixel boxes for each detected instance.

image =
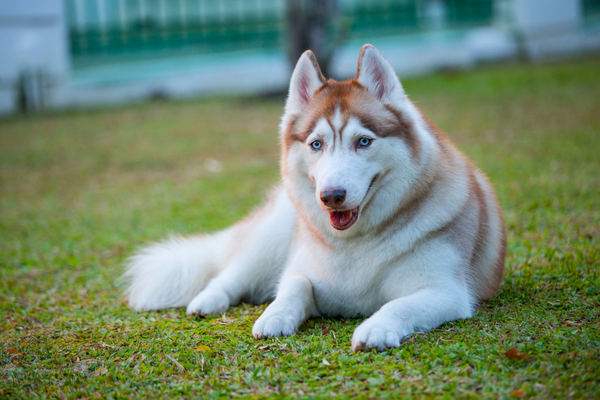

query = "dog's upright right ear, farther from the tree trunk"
[355,44,404,104]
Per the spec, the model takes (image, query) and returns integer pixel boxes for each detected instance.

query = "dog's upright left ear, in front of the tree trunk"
[285,50,325,114]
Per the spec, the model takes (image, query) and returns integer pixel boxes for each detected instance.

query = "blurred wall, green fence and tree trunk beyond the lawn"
[0,0,600,114]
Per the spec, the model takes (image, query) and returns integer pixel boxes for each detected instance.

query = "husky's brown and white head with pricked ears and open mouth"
[281,45,420,231]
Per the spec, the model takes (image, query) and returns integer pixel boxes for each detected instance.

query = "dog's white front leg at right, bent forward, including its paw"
[352,285,472,351]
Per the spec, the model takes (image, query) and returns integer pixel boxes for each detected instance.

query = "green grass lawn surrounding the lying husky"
[0,58,600,399]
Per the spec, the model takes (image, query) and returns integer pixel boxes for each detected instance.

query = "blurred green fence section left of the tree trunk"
[66,0,284,65]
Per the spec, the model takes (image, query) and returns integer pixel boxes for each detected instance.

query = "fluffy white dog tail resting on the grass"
[123,230,231,311]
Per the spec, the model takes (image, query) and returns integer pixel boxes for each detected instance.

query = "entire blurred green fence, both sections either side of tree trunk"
[65,0,496,67]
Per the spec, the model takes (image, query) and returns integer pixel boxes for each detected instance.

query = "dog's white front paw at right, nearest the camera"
[352,318,405,351]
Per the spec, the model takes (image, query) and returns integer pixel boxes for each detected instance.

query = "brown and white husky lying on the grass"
[125,45,506,351]
